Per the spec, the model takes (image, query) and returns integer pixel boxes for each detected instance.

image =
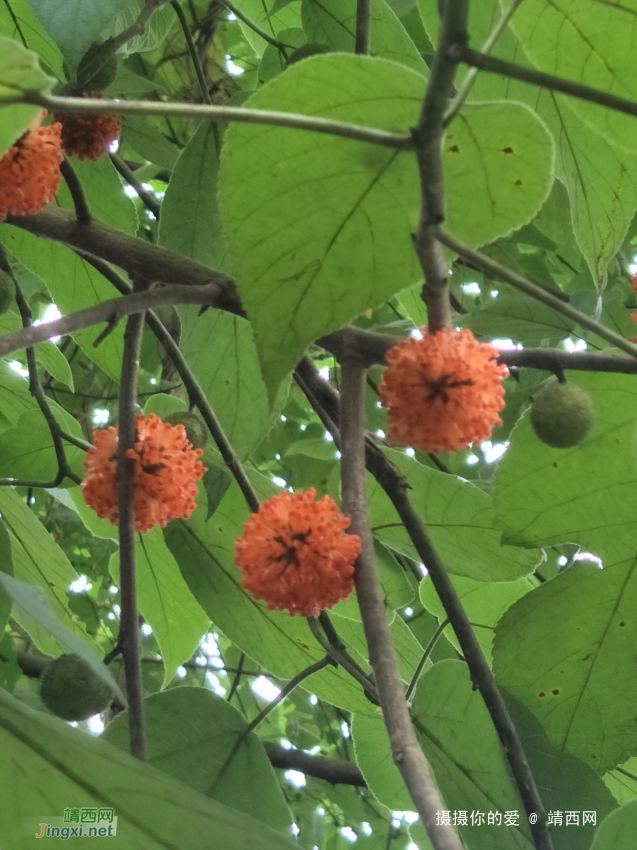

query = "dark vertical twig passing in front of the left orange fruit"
[117,312,146,759]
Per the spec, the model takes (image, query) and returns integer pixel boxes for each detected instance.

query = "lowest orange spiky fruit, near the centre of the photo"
[235,487,361,617]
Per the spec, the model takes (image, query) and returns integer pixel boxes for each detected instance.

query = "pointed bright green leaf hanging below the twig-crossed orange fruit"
[71,490,210,686]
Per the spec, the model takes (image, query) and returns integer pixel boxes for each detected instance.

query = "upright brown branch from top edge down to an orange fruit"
[414,0,469,333]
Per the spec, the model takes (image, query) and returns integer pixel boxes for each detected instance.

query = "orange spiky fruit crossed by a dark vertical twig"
[82,413,206,531]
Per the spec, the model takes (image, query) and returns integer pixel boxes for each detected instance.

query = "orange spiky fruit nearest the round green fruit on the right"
[379,330,508,452]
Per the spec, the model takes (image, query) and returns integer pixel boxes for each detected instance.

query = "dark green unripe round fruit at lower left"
[40,655,113,720]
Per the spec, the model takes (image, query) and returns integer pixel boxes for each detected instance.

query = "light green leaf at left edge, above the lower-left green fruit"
[0,487,91,655]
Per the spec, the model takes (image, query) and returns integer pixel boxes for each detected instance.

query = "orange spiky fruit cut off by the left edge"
[0,112,64,221]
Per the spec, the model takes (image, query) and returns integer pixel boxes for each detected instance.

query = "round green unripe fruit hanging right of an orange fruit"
[531,382,595,449]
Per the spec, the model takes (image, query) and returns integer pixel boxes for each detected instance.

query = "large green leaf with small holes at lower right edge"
[493,558,637,771]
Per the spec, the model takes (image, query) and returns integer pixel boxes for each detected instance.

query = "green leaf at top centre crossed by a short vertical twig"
[301,0,426,74]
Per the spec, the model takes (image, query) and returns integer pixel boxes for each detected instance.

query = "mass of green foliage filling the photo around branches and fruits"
[0,0,637,850]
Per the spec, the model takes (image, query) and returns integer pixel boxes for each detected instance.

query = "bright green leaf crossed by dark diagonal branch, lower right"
[420,576,535,663]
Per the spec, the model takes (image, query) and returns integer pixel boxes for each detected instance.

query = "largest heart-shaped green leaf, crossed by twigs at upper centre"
[221,54,552,392]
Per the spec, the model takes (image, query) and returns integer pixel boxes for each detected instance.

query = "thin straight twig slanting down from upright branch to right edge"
[435,228,637,358]
